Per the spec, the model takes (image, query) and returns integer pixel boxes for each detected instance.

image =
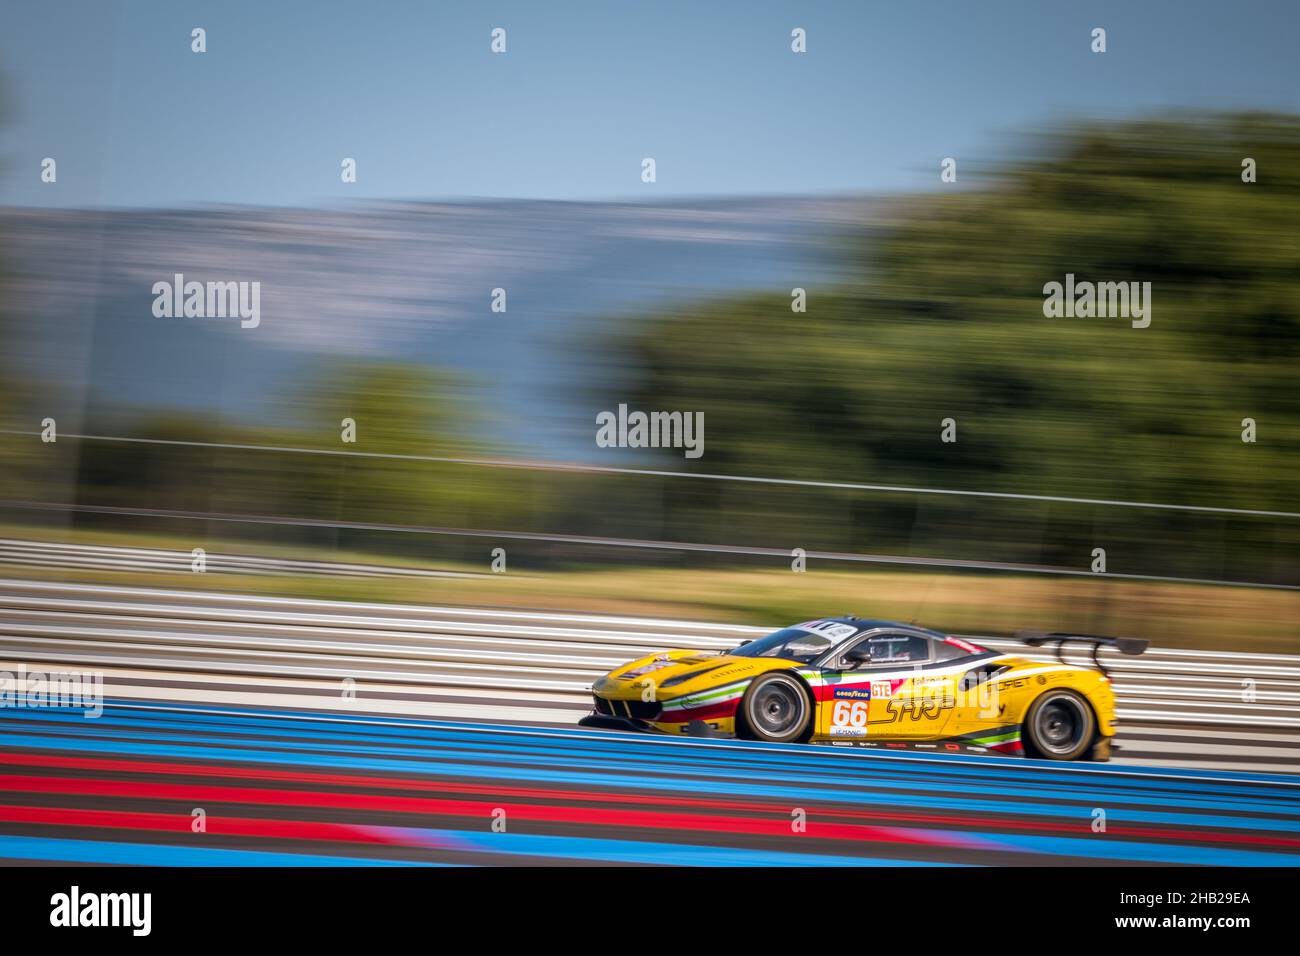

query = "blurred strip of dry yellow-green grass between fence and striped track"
[0,525,1300,653]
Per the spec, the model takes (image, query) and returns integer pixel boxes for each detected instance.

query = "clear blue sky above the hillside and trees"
[0,0,1300,207]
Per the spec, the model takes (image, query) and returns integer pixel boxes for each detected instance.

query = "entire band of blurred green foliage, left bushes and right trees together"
[0,114,1300,621]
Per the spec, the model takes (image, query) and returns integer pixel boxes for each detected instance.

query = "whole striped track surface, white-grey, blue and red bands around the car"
[0,580,1300,865]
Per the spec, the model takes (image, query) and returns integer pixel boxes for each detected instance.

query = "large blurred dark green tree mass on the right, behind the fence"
[602,116,1300,583]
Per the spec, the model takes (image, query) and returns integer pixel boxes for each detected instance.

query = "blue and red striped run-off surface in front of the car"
[0,704,1300,865]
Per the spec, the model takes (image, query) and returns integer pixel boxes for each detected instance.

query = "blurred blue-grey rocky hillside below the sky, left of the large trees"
[0,198,875,454]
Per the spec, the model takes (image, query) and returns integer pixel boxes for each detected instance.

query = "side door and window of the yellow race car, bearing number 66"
[818,630,956,740]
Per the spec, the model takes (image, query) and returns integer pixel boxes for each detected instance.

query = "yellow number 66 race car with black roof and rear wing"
[580,617,1147,760]
